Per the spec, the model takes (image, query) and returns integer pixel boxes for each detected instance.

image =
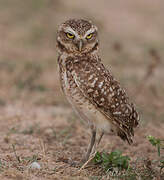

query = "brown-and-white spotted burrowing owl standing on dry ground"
[57,19,139,161]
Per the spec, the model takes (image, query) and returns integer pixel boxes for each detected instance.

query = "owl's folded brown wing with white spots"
[72,58,139,143]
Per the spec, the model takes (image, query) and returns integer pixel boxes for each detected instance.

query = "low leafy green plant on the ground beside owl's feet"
[93,150,130,172]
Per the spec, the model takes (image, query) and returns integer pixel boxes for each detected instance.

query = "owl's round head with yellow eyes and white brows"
[57,19,98,54]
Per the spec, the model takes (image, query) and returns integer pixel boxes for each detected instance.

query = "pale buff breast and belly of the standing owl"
[61,67,111,132]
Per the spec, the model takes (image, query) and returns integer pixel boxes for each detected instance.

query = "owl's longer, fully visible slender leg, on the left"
[82,128,96,163]
